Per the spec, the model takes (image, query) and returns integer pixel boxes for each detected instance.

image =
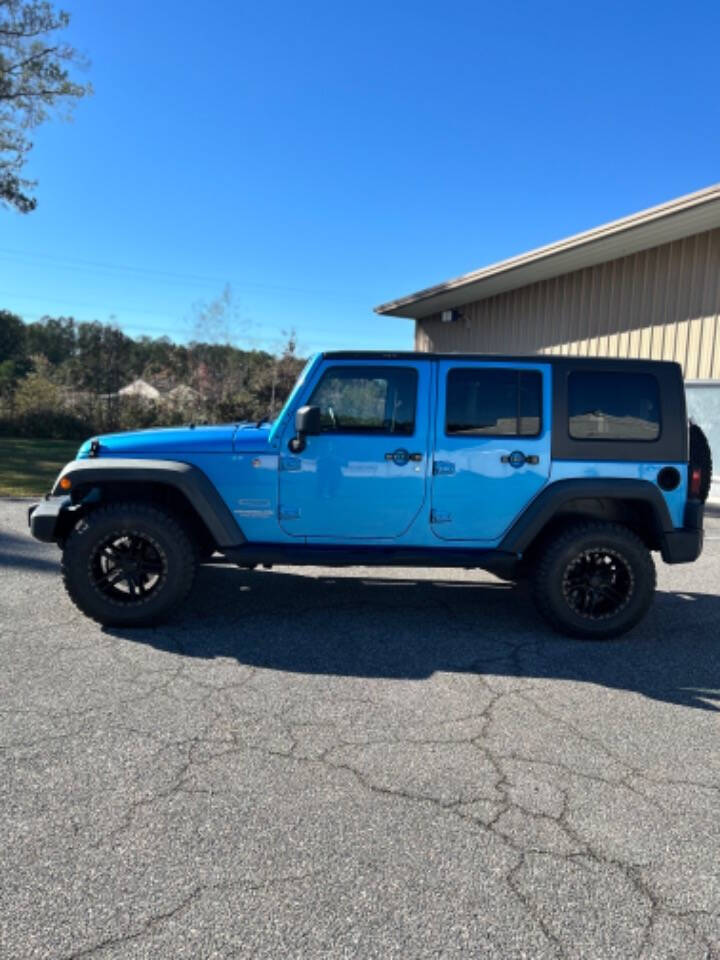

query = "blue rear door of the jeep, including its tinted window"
[431,359,551,542]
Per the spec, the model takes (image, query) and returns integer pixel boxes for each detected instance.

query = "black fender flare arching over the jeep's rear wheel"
[499,477,674,554]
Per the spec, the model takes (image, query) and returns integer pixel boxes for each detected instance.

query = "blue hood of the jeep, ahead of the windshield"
[77,423,239,460]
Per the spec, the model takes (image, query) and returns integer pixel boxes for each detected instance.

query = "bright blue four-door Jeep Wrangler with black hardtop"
[30,352,711,638]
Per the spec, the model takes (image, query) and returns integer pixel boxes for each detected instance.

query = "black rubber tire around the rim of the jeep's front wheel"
[61,501,197,627]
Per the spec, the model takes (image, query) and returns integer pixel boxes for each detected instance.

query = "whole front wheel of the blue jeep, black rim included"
[62,503,197,626]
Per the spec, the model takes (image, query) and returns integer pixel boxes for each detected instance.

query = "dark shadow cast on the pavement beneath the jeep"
[106,566,720,710]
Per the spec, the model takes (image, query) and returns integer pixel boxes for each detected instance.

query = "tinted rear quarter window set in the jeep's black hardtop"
[568,371,660,441]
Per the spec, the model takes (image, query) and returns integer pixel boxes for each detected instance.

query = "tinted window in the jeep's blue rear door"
[445,367,542,437]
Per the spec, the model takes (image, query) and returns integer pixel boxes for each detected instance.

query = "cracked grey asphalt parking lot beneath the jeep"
[0,500,720,960]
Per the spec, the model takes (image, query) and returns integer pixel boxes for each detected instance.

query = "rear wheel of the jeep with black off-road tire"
[532,521,655,640]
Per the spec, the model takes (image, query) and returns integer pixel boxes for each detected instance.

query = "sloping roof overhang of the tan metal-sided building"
[375,184,720,319]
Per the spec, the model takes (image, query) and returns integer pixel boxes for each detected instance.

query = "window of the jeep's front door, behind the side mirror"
[309,366,418,436]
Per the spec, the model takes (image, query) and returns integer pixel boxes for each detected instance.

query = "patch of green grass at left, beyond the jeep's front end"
[0,437,80,497]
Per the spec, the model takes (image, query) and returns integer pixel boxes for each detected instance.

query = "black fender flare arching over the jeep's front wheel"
[52,457,245,548]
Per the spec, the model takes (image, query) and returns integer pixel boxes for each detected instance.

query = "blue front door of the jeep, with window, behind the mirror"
[279,359,431,543]
